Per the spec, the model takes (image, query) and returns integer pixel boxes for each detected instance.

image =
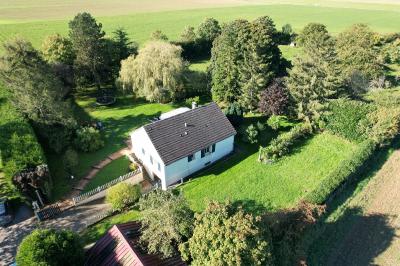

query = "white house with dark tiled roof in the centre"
[131,103,236,189]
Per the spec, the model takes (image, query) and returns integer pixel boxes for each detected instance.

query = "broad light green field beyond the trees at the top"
[0,4,400,51]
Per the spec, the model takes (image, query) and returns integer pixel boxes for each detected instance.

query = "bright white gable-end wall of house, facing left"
[131,127,165,187]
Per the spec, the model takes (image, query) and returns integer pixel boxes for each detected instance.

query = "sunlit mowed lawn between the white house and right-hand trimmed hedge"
[181,133,356,212]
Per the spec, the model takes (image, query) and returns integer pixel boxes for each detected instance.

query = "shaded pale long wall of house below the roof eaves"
[163,136,234,189]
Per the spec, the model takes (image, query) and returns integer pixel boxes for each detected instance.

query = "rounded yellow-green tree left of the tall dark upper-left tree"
[42,34,75,65]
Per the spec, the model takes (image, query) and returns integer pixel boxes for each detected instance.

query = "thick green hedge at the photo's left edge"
[0,84,46,198]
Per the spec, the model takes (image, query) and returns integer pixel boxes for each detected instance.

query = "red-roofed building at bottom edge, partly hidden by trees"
[85,222,186,266]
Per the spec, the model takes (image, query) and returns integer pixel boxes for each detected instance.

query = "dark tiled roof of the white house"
[144,103,236,165]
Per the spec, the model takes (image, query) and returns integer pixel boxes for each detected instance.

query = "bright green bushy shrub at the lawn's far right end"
[324,99,373,142]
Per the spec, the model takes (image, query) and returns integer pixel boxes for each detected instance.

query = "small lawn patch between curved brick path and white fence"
[85,157,130,191]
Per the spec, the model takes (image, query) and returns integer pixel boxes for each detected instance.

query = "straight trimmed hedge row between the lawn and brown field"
[305,140,377,204]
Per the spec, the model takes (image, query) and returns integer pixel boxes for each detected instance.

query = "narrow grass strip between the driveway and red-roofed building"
[81,209,140,244]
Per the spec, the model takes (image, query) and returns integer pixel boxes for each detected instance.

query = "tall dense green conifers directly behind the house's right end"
[210,17,282,110]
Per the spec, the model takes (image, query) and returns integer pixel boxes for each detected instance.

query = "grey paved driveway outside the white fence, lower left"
[0,200,110,266]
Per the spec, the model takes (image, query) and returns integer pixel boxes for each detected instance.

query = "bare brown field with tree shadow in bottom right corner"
[326,150,400,266]
